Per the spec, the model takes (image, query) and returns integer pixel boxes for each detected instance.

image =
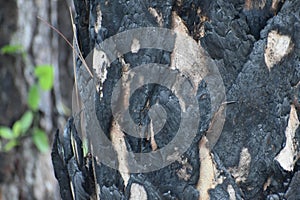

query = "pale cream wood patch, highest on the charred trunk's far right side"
[264,30,293,70]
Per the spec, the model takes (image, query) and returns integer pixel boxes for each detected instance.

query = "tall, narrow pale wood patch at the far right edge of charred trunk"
[275,104,299,171]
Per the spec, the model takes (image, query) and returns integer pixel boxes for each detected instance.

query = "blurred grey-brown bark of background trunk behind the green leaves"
[0,0,73,200]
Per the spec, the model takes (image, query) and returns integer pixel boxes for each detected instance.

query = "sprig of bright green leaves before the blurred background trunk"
[0,45,54,152]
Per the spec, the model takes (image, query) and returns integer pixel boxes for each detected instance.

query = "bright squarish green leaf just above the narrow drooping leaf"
[34,65,54,91]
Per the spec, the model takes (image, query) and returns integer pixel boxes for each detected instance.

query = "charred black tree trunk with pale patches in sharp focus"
[52,0,300,199]
